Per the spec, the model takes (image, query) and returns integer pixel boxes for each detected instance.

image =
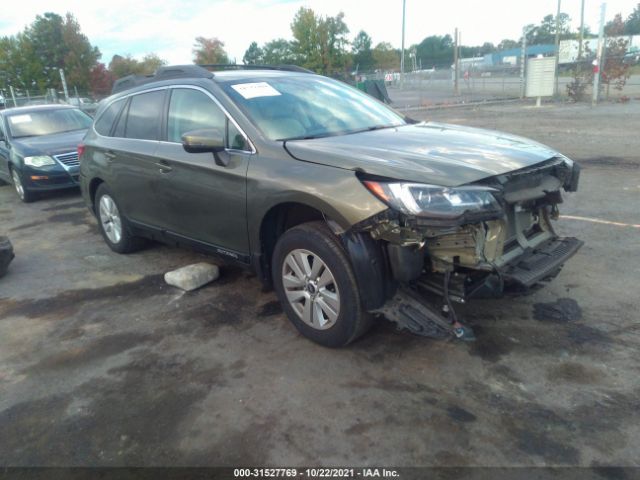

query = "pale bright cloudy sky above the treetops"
[0,0,637,64]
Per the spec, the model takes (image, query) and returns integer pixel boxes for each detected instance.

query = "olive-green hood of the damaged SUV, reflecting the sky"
[285,122,560,187]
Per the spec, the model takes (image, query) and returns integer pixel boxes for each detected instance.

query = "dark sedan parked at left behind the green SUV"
[0,105,92,202]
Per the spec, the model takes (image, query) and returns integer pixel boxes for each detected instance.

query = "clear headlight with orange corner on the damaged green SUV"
[364,180,502,220]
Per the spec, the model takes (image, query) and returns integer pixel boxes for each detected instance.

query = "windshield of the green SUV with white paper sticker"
[222,75,406,140]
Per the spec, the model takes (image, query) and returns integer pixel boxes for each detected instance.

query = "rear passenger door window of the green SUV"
[125,90,165,140]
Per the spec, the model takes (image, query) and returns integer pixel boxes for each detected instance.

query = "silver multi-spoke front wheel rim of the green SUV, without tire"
[282,249,340,330]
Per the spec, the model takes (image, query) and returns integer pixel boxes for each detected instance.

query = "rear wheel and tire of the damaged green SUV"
[94,183,144,253]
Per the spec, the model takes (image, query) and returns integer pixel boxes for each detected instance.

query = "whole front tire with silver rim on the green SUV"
[272,222,371,347]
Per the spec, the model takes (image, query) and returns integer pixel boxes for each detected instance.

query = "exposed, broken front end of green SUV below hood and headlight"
[358,157,583,336]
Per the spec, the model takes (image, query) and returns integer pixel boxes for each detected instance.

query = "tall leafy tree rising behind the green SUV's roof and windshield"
[291,7,349,74]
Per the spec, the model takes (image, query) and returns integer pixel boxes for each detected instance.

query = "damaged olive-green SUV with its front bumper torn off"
[79,66,582,346]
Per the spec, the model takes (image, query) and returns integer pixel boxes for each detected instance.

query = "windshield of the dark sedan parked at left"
[7,108,92,138]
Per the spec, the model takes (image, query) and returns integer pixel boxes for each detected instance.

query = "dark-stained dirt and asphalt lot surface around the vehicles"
[0,102,640,466]
